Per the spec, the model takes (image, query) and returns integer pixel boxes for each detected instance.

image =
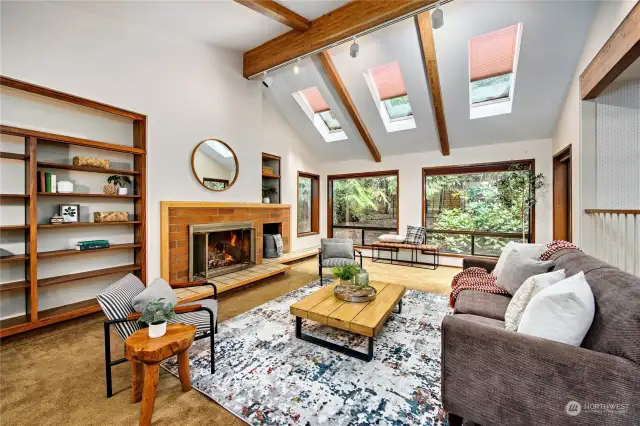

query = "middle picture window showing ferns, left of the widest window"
[327,170,398,246]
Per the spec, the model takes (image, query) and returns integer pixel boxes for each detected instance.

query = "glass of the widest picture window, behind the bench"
[424,171,530,256]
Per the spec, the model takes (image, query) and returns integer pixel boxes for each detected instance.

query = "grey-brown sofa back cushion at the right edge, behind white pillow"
[582,266,640,364]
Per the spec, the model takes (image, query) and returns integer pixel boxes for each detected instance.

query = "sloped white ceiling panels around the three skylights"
[263,0,597,161]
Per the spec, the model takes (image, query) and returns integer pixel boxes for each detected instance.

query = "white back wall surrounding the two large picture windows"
[320,139,552,266]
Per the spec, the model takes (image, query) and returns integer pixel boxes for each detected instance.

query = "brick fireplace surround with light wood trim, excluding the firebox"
[160,201,291,282]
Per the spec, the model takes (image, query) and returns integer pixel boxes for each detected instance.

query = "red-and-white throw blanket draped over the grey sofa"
[449,240,579,308]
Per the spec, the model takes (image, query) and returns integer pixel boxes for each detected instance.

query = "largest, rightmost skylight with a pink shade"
[469,23,522,119]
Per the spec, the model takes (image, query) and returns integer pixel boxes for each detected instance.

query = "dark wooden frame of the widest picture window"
[422,158,536,259]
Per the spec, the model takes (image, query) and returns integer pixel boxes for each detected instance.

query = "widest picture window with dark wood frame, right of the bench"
[423,160,534,256]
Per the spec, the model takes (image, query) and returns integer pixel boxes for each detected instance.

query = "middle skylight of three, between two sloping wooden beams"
[364,62,416,132]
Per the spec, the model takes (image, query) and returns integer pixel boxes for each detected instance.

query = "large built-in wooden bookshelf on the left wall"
[0,77,147,338]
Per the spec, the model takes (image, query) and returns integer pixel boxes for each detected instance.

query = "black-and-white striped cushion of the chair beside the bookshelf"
[96,274,145,340]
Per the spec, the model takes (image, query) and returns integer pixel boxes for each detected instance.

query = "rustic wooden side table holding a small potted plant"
[124,324,196,426]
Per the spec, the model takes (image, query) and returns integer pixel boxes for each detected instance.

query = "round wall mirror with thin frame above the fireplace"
[191,139,238,191]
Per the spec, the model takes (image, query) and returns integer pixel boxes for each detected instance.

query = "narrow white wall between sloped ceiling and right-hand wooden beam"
[553,1,636,245]
